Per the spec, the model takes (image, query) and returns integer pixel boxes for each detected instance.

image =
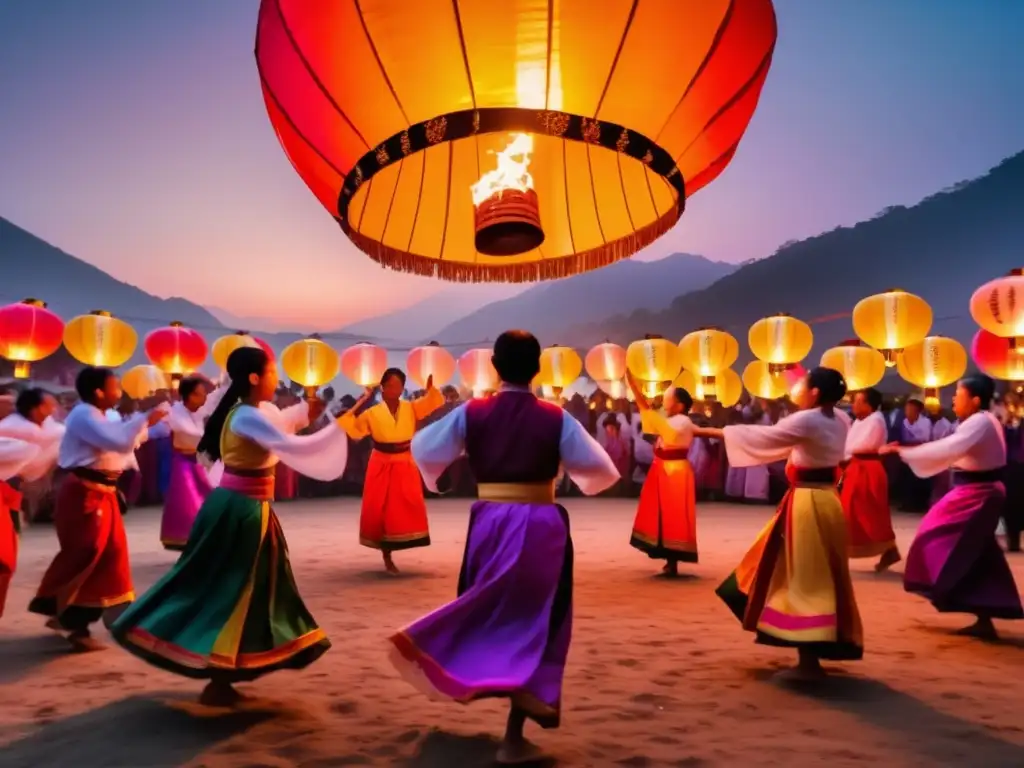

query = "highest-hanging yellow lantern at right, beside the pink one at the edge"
[852,288,932,368]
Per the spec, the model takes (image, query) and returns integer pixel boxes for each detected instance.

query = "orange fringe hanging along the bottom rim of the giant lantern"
[347,207,680,283]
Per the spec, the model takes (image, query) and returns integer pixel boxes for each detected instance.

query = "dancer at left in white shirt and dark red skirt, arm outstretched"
[29,367,165,650]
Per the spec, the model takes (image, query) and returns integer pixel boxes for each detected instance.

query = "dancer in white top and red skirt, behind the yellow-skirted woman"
[840,388,900,572]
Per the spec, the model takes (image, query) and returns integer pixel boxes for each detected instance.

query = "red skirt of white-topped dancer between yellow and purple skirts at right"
[840,456,896,558]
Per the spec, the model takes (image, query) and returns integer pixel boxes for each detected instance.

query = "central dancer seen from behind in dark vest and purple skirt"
[391,331,618,765]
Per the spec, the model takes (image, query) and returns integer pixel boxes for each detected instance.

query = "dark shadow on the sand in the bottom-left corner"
[0,696,273,768]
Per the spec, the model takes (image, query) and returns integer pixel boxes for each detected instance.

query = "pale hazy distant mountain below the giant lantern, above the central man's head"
[437,253,736,344]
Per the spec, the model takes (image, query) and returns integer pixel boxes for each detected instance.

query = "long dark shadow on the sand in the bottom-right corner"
[757,670,1024,768]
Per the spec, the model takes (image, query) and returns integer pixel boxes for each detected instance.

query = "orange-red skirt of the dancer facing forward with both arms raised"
[359,451,430,551]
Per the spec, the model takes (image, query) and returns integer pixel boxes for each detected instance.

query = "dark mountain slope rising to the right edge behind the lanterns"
[562,153,1024,361]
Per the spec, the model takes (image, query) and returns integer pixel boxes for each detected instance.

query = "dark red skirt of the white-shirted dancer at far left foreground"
[29,474,135,616]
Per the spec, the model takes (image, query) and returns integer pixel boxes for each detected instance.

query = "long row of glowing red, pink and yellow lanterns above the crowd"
[0,278,1024,409]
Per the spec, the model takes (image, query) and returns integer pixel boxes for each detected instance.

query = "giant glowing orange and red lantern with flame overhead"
[256,0,776,283]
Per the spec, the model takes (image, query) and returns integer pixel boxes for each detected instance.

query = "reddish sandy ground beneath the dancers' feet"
[0,500,1024,768]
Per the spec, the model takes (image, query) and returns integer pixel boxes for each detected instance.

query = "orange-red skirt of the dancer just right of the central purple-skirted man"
[630,452,697,562]
